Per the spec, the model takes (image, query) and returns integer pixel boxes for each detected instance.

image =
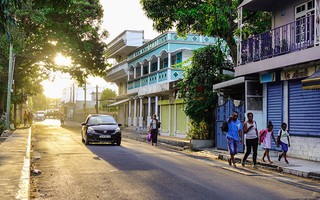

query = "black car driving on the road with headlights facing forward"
[81,114,121,145]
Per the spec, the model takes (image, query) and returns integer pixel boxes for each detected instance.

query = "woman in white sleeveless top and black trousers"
[241,112,258,169]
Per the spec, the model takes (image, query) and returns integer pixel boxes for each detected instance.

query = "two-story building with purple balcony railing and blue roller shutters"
[214,0,320,161]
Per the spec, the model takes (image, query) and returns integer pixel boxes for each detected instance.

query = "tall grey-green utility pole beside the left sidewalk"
[5,43,13,130]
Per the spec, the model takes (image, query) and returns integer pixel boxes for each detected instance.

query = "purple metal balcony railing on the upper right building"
[240,15,314,65]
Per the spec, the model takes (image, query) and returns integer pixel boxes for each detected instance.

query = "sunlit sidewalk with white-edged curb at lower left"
[0,128,31,199]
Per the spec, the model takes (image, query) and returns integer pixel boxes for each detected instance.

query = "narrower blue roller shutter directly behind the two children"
[266,82,283,149]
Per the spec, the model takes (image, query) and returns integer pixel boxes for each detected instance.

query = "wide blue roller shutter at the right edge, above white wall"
[288,80,320,136]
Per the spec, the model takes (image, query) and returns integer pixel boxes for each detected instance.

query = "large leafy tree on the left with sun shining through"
[0,0,107,122]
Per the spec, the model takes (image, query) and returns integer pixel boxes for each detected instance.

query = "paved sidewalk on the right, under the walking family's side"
[122,129,320,180]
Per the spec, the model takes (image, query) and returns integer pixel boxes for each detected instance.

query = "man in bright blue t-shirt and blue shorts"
[226,111,242,167]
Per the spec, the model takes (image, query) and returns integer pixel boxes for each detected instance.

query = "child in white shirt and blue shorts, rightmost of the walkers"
[277,123,290,164]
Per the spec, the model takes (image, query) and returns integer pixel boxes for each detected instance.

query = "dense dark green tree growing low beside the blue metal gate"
[178,42,232,139]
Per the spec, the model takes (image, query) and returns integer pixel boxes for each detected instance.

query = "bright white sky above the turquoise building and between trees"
[42,0,159,98]
